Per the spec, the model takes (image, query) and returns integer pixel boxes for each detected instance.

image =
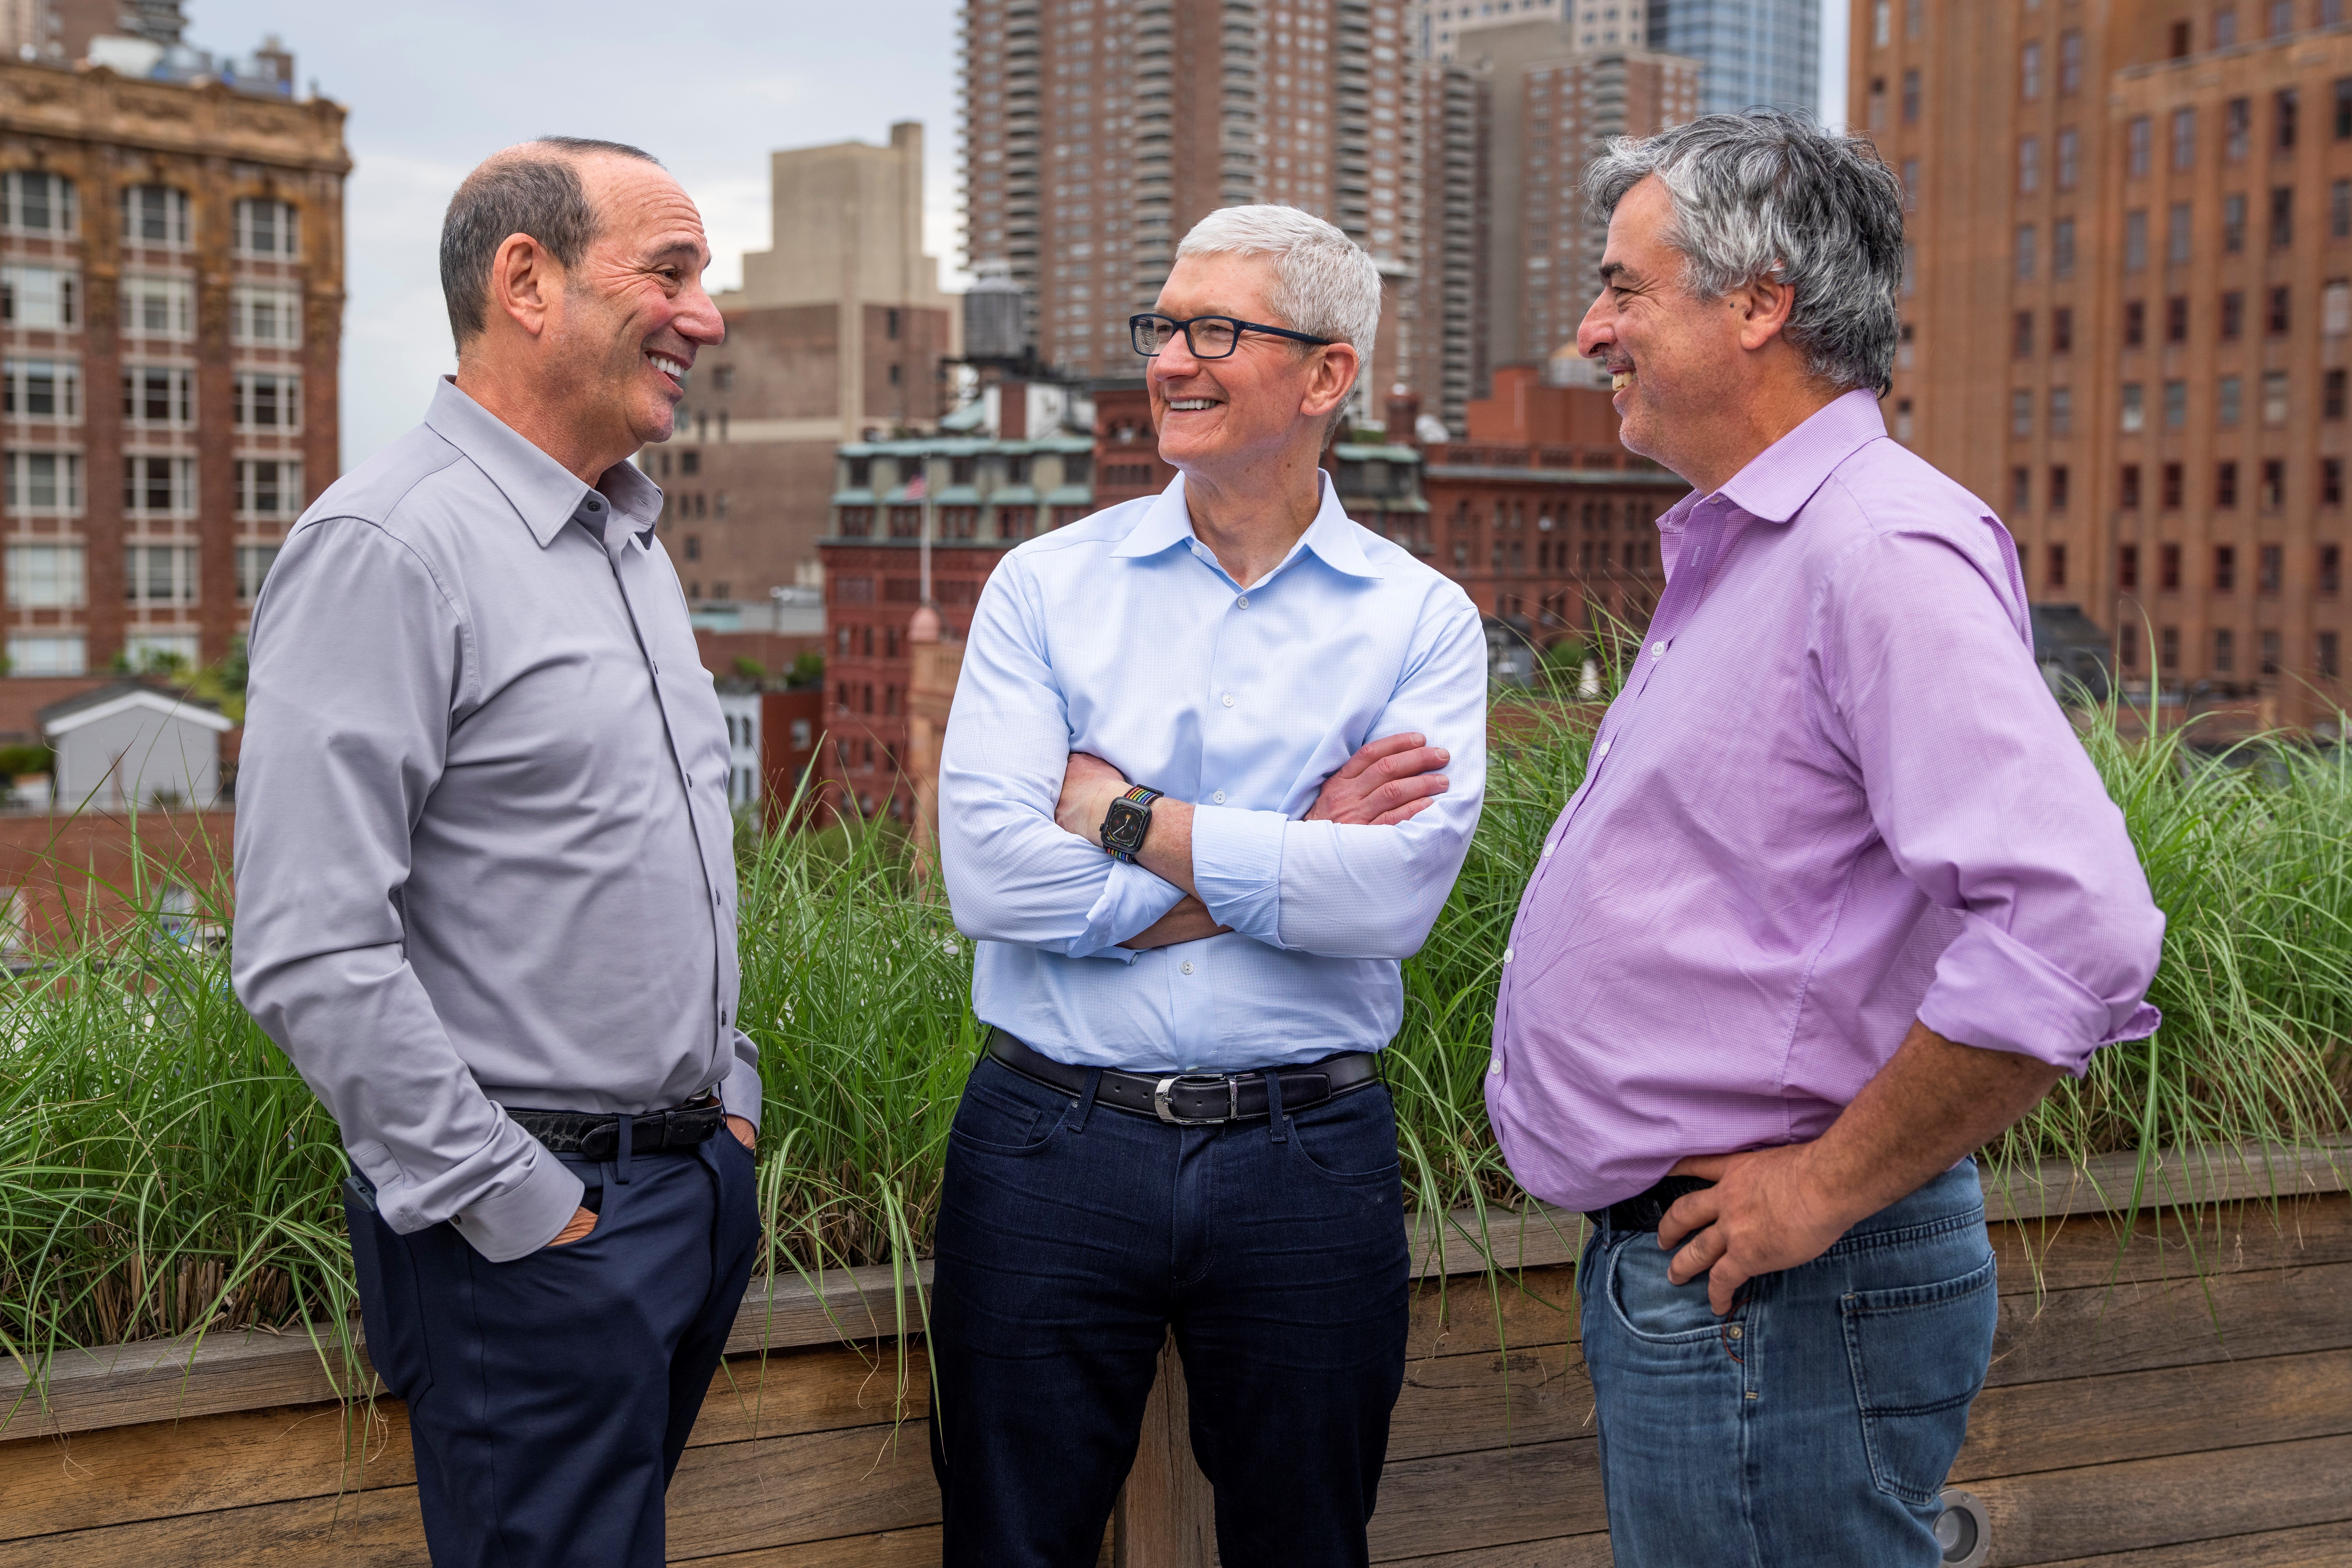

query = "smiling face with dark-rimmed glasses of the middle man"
[1143,254,1355,475]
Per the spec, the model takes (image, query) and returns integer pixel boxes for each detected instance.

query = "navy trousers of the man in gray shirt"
[346,1128,760,1568]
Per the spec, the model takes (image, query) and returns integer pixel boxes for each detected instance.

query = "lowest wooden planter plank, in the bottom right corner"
[1969,1436,2352,1568]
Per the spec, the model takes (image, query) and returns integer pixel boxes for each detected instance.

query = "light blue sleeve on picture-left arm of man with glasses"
[939,557,1183,962]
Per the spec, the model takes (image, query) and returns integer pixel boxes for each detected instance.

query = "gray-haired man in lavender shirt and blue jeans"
[1486,113,2164,1568]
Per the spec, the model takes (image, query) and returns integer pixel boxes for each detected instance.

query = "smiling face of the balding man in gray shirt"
[548,155,727,461]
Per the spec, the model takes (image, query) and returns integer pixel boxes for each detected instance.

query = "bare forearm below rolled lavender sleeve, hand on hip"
[1806,1023,2063,1222]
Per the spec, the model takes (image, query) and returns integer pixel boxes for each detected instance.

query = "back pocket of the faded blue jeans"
[1839,1255,2001,1505]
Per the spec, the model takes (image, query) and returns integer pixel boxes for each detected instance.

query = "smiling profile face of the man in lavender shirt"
[1576,174,1747,477]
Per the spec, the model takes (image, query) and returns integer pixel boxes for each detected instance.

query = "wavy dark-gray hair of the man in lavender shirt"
[1585,108,1903,395]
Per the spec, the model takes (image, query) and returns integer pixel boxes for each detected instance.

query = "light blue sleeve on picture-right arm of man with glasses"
[1192,588,1486,959]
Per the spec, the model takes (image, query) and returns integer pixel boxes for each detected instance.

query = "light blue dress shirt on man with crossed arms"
[939,475,1486,1072]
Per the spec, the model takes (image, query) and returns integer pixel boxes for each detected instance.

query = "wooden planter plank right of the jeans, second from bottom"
[1952,1349,2352,1486]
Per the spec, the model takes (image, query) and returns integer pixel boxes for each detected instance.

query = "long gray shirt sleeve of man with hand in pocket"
[233,517,581,1262]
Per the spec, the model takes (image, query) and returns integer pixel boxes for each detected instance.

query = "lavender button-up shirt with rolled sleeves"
[1486,390,2164,1208]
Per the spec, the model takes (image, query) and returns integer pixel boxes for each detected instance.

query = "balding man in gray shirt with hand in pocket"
[235,139,760,1568]
